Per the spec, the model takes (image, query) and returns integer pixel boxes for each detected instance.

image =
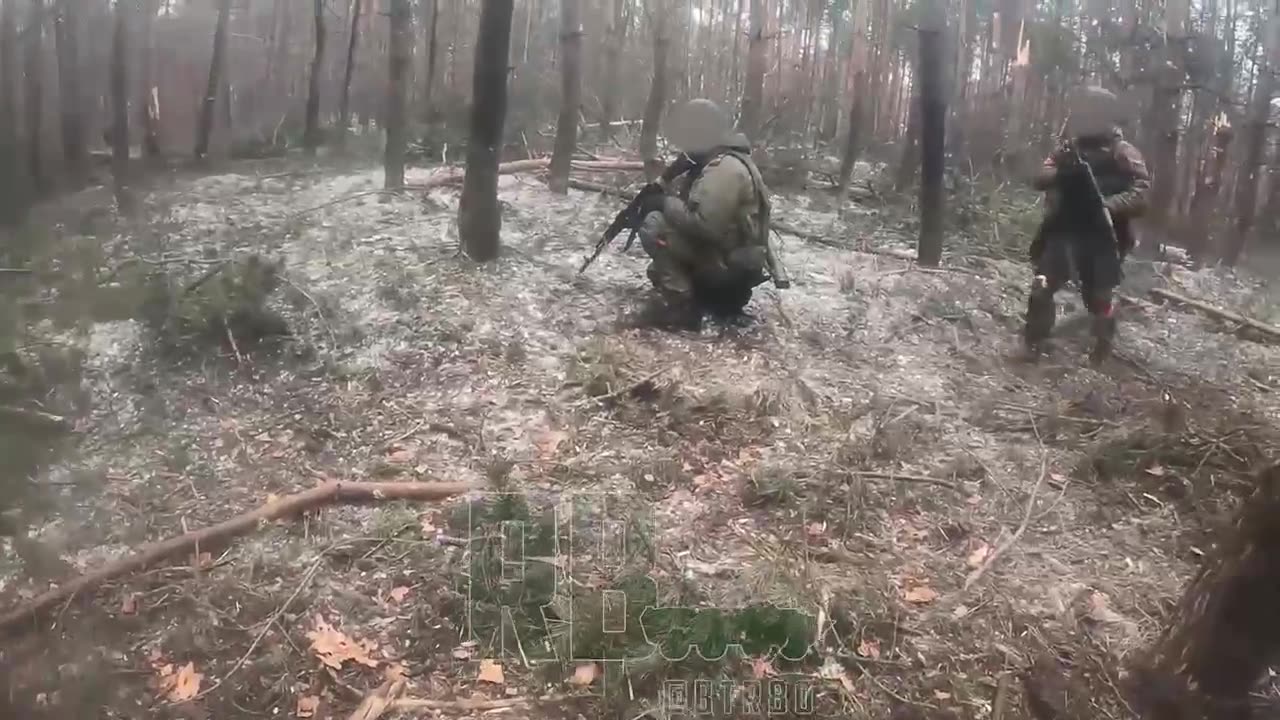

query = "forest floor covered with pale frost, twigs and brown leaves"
[0,152,1280,720]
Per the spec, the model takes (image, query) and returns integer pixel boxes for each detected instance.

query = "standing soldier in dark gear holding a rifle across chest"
[1024,87,1151,365]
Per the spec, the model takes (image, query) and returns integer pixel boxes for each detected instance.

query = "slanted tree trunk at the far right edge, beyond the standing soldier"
[1222,8,1280,266]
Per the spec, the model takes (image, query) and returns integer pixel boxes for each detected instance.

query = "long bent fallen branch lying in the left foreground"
[0,480,475,634]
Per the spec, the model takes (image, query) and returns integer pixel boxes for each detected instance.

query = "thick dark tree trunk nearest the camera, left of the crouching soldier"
[458,0,515,263]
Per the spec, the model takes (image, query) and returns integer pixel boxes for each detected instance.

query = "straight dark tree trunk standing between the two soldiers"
[913,0,947,266]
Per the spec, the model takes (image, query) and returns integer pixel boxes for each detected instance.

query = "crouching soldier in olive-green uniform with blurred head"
[639,100,788,331]
